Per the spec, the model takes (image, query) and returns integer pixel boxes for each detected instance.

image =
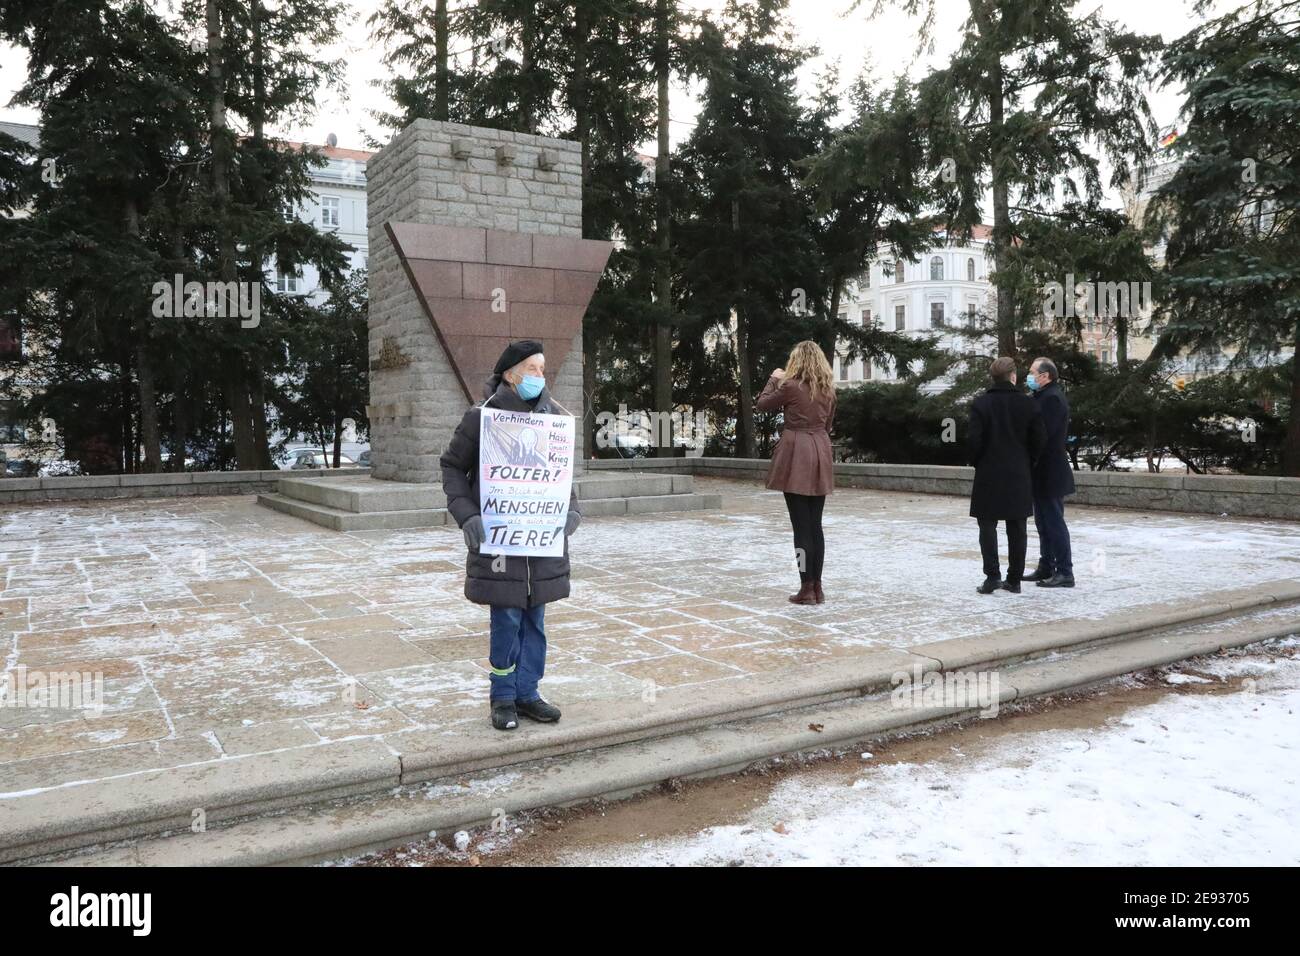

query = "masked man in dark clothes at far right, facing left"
[1024,358,1074,588]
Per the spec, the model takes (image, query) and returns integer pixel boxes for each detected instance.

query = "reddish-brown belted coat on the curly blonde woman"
[758,376,835,494]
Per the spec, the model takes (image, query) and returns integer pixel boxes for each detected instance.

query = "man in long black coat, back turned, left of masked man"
[967,355,1047,594]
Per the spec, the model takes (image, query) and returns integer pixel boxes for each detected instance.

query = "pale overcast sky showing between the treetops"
[0,0,1211,195]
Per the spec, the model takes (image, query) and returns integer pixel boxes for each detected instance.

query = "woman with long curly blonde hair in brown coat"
[758,341,835,604]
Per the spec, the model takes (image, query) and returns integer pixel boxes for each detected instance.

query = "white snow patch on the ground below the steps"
[559,639,1300,866]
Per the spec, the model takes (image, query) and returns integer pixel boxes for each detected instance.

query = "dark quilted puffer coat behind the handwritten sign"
[438,382,579,607]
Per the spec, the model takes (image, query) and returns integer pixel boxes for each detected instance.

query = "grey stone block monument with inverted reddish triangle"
[367,120,612,483]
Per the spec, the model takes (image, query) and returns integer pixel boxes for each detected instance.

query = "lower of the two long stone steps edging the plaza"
[38,605,1300,866]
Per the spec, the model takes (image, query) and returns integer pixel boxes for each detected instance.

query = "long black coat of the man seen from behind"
[966,382,1047,520]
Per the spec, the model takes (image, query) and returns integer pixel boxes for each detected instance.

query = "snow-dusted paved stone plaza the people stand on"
[0,479,1300,797]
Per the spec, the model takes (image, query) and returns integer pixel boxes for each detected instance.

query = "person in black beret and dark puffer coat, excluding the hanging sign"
[438,339,582,730]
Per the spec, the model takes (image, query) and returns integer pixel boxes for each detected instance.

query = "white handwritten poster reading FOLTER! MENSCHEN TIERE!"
[478,407,576,558]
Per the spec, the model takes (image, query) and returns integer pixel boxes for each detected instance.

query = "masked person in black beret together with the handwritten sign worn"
[439,341,582,730]
